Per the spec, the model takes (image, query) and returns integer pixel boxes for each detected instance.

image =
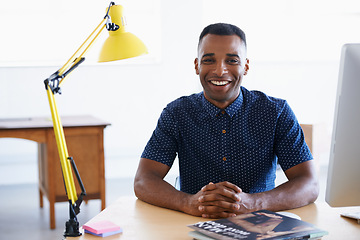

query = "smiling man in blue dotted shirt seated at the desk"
[134,23,319,218]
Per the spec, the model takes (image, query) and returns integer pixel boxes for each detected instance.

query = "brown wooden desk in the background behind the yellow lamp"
[0,116,110,229]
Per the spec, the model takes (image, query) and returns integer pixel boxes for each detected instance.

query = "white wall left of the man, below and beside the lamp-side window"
[0,0,202,184]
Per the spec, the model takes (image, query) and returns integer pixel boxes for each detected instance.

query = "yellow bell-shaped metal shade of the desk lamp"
[99,5,148,62]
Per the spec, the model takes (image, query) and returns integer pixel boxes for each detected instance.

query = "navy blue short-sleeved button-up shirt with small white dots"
[141,87,312,194]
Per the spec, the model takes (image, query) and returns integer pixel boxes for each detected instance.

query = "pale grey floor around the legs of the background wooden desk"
[0,168,327,240]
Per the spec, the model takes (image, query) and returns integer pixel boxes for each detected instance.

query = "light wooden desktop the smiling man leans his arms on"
[71,197,360,240]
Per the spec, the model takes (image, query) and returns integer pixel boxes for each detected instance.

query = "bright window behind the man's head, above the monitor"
[203,0,360,62]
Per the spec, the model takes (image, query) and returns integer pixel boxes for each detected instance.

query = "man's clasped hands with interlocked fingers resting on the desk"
[194,182,250,218]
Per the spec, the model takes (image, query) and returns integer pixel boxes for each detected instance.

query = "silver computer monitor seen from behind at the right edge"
[325,44,360,207]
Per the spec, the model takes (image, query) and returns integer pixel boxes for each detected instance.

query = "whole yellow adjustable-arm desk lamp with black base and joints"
[44,2,147,237]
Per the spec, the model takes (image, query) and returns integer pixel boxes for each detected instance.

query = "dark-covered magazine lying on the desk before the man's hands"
[188,210,328,240]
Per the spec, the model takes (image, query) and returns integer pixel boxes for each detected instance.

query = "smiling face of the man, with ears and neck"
[194,34,249,109]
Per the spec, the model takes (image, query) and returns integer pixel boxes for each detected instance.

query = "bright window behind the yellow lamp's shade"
[0,0,161,67]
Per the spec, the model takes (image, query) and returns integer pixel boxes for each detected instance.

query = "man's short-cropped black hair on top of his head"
[199,23,246,47]
